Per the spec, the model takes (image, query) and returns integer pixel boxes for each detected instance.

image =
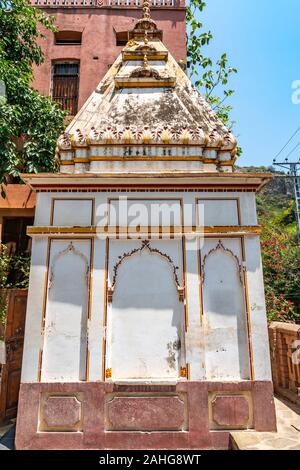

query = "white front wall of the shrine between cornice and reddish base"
[22,192,270,382]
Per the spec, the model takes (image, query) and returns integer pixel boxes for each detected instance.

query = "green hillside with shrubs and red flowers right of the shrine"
[237,167,300,323]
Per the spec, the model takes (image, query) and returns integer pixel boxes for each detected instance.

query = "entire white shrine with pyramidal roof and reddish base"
[16,1,276,449]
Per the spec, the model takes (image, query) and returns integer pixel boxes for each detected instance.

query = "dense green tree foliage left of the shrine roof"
[0,0,65,193]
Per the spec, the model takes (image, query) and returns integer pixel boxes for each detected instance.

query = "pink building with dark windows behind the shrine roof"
[32,0,186,115]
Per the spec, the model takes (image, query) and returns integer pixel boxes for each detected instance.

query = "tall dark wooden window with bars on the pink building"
[52,62,79,116]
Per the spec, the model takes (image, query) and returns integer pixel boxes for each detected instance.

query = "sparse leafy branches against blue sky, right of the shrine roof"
[187,0,241,136]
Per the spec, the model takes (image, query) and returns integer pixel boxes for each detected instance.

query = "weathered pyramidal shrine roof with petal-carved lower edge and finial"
[58,1,237,171]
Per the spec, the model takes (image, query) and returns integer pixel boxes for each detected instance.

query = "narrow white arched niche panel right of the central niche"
[202,239,250,380]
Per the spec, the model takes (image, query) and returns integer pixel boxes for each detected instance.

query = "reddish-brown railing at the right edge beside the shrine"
[269,323,300,403]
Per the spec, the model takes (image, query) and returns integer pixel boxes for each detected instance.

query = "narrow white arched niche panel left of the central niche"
[41,240,91,382]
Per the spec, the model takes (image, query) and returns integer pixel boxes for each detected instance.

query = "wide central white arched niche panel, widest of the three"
[106,241,184,380]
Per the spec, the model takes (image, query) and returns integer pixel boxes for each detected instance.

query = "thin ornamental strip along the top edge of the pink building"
[31,0,185,8]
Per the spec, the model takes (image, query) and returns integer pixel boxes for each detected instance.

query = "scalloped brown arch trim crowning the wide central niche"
[108,240,185,302]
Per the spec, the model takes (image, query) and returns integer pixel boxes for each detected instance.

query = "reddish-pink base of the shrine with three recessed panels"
[16,382,276,450]
